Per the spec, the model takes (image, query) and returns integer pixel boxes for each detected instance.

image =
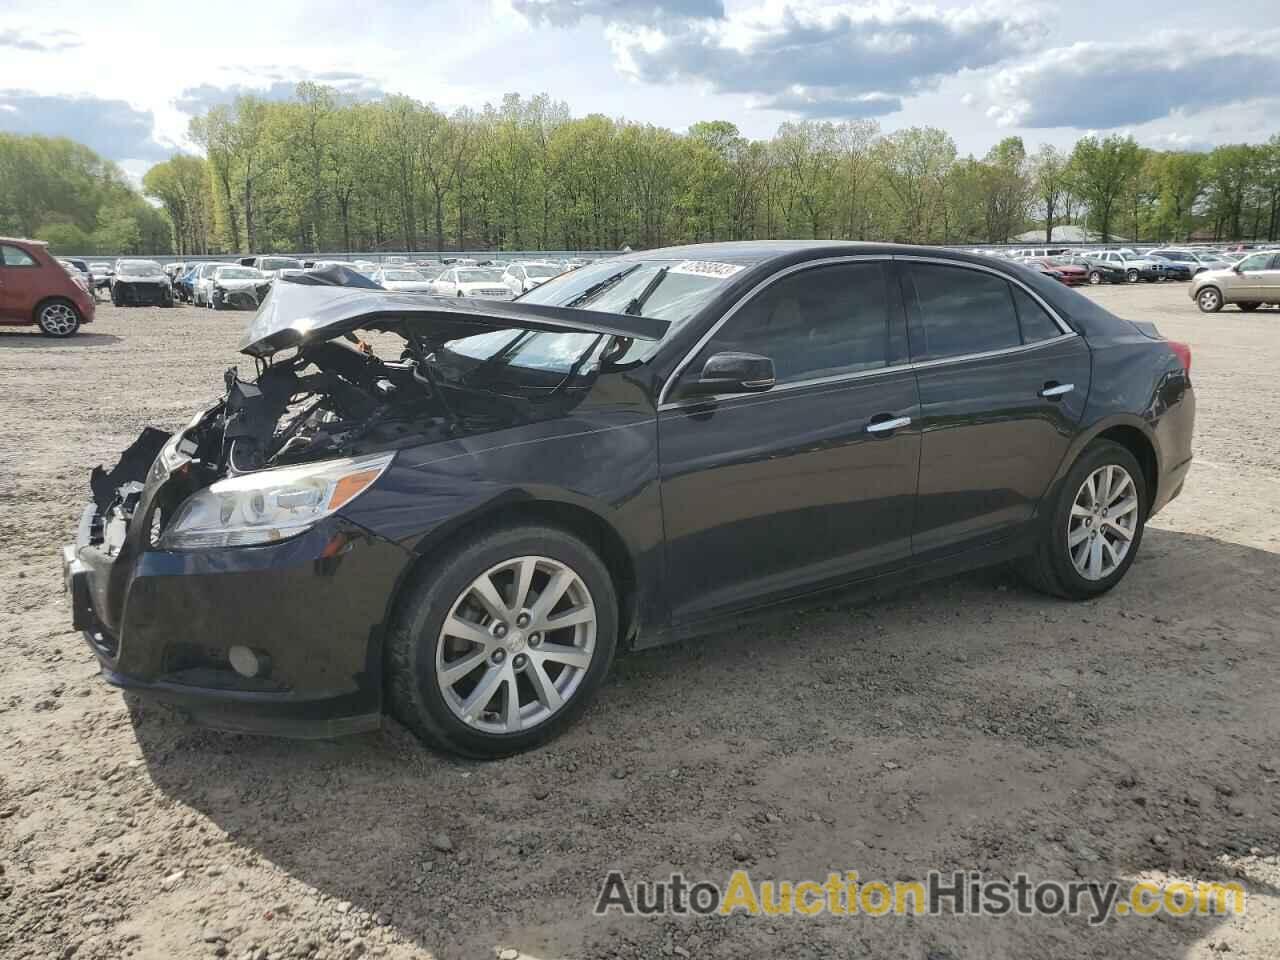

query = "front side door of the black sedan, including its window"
[658,259,920,625]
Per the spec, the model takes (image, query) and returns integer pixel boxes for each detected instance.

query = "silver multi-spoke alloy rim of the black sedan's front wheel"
[435,557,596,733]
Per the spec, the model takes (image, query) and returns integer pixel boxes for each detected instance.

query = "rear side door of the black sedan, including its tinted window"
[899,257,1091,561]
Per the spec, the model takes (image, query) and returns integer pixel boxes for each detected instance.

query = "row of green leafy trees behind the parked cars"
[0,83,1280,255]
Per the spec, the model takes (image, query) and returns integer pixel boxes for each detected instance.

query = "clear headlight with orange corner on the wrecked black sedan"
[160,453,396,550]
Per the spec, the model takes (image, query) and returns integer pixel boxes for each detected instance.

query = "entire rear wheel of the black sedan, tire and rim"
[1018,440,1151,600]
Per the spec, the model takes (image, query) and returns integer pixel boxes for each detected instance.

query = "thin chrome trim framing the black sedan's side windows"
[658,253,1080,413]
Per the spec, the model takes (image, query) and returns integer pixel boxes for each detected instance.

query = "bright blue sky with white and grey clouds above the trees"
[0,0,1280,179]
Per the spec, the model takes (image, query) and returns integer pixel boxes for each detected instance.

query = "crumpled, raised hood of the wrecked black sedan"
[241,266,668,357]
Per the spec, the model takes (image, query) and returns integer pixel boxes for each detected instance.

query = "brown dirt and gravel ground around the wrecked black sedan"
[0,284,1280,960]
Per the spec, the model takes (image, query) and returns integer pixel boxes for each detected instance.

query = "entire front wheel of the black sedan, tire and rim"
[385,525,618,759]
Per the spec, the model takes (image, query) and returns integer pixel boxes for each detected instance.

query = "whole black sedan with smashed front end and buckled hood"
[63,242,1196,756]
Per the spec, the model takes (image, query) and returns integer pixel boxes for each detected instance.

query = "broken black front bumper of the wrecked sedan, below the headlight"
[61,465,410,737]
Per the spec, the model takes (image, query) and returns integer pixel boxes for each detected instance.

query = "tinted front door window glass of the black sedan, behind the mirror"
[689,262,888,384]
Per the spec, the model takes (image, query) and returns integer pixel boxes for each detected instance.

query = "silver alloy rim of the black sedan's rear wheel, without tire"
[1066,463,1138,580]
